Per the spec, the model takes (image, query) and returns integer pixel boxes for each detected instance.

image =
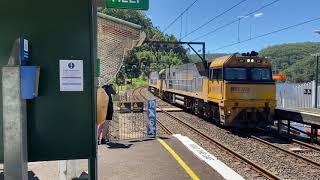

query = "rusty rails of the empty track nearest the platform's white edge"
[139,88,280,179]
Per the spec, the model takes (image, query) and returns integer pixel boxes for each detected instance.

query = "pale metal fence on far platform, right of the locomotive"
[276,81,320,109]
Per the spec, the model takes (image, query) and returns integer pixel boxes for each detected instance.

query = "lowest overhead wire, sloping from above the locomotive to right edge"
[213,17,320,51]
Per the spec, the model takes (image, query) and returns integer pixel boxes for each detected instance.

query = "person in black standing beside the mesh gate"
[101,84,116,144]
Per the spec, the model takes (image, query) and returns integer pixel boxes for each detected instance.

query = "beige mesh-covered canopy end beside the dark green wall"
[97,13,146,86]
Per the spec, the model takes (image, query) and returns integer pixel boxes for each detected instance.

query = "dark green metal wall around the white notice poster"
[0,0,96,161]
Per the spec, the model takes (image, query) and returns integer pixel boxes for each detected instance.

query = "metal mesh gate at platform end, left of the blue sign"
[108,98,147,142]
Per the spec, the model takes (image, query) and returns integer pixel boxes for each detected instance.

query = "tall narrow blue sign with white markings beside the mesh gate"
[147,100,157,137]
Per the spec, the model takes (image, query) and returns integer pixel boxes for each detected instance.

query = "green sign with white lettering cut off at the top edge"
[106,0,149,10]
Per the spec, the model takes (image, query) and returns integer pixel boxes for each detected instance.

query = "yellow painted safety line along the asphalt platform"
[157,139,200,180]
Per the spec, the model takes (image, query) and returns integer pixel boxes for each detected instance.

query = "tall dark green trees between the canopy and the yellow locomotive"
[102,9,190,78]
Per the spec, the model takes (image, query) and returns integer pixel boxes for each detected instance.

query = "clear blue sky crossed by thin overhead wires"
[145,0,320,53]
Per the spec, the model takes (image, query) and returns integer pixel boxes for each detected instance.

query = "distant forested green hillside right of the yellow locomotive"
[260,42,320,83]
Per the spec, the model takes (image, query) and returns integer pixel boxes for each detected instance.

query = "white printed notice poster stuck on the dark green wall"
[59,60,83,91]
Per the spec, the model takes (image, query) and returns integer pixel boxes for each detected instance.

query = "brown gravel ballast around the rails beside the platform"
[143,90,320,179]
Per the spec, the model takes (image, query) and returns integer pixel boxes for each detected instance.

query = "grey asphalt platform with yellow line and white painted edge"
[0,135,242,180]
